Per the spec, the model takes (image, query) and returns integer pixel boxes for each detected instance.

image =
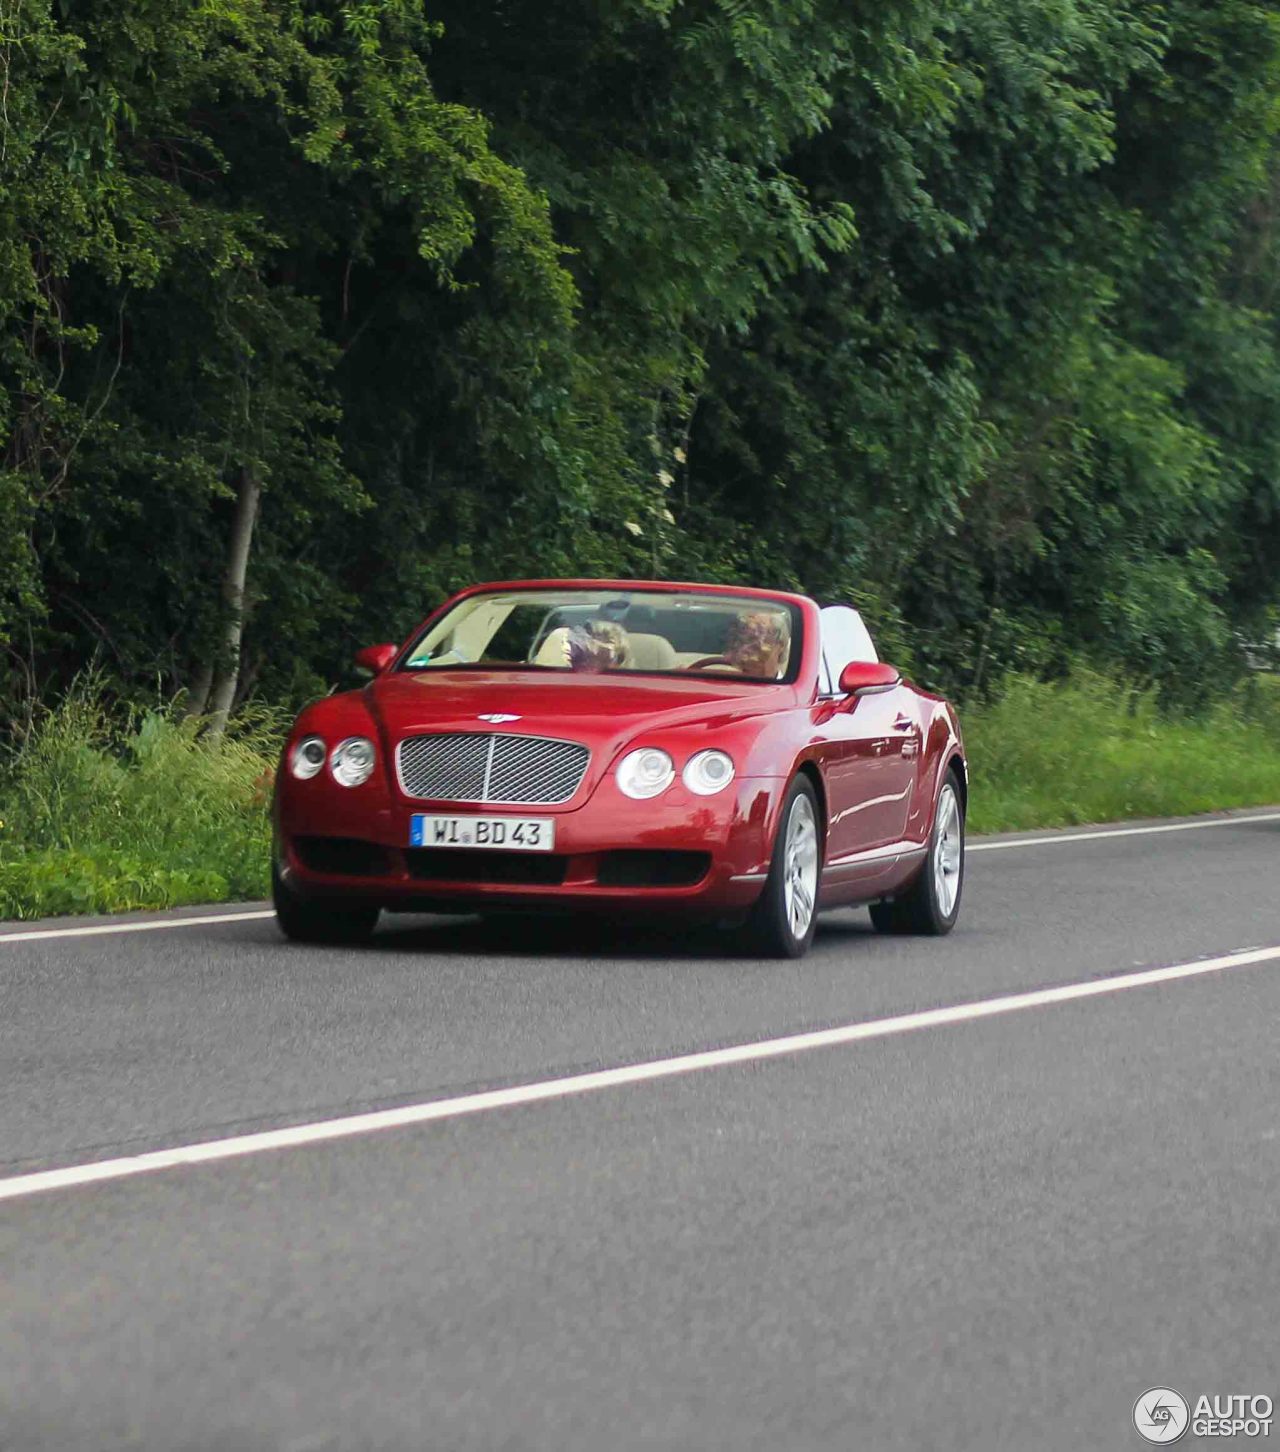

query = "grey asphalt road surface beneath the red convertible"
[0,816,1280,1452]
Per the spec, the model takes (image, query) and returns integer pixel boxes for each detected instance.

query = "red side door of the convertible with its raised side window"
[816,605,923,865]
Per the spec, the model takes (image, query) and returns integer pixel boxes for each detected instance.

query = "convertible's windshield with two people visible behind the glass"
[401,590,801,681]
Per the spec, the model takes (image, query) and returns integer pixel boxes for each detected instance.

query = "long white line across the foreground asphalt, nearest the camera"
[0,947,1280,1199]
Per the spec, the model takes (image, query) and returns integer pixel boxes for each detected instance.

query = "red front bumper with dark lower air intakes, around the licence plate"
[276,777,785,918]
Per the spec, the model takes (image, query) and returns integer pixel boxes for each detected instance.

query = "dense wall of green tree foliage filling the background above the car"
[0,0,1280,729]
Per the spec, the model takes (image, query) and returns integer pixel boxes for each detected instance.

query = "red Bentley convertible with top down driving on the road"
[273,579,968,957]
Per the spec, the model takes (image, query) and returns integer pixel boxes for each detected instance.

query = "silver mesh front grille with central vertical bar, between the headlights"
[396,732,591,806]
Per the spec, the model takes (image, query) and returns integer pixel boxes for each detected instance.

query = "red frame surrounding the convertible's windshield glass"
[392,579,808,685]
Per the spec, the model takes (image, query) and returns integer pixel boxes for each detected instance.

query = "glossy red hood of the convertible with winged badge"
[364,669,794,777]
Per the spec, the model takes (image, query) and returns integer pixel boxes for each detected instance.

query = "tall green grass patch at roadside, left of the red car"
[0,681,280,918]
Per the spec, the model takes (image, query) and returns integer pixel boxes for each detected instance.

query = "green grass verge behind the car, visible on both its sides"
[0,672,1280,918]
